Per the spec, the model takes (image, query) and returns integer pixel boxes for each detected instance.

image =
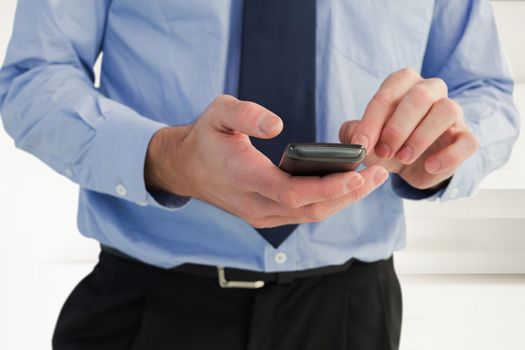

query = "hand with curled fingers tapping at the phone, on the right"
[339,68,479,189]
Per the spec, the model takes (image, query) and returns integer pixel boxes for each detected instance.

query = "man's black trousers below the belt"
[53,252,401,350]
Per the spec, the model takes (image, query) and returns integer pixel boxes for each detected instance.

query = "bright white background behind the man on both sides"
[0,0,525,350]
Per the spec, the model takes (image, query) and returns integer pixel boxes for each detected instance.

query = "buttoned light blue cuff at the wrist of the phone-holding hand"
[93,101,190,210]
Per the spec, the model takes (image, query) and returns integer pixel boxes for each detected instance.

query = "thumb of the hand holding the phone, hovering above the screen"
[213,96,283,139]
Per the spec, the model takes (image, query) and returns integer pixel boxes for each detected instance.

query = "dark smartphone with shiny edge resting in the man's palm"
[279,143,366,176]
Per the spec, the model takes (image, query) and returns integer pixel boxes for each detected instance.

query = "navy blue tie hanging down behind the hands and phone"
[239,0,316,248]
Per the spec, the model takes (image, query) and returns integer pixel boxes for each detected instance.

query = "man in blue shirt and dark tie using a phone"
[0,0,518,349]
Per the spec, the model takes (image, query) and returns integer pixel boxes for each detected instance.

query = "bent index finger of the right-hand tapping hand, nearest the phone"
[351,68,423,150]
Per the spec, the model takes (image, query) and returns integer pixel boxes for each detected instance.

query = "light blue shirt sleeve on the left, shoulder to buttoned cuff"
[0,0,188,210]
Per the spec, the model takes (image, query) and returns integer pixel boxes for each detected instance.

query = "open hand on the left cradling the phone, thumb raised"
[145,95,388,228]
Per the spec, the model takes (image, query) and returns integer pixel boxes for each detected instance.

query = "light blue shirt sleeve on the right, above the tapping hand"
[390,0,519,201]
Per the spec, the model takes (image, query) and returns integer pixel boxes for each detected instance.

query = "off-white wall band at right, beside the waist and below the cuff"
[396,189,525,274]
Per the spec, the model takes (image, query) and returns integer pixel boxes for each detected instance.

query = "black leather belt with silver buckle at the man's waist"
[101,245,358,288]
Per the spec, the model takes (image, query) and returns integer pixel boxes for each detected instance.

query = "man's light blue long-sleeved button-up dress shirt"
[0,0,518,271]
